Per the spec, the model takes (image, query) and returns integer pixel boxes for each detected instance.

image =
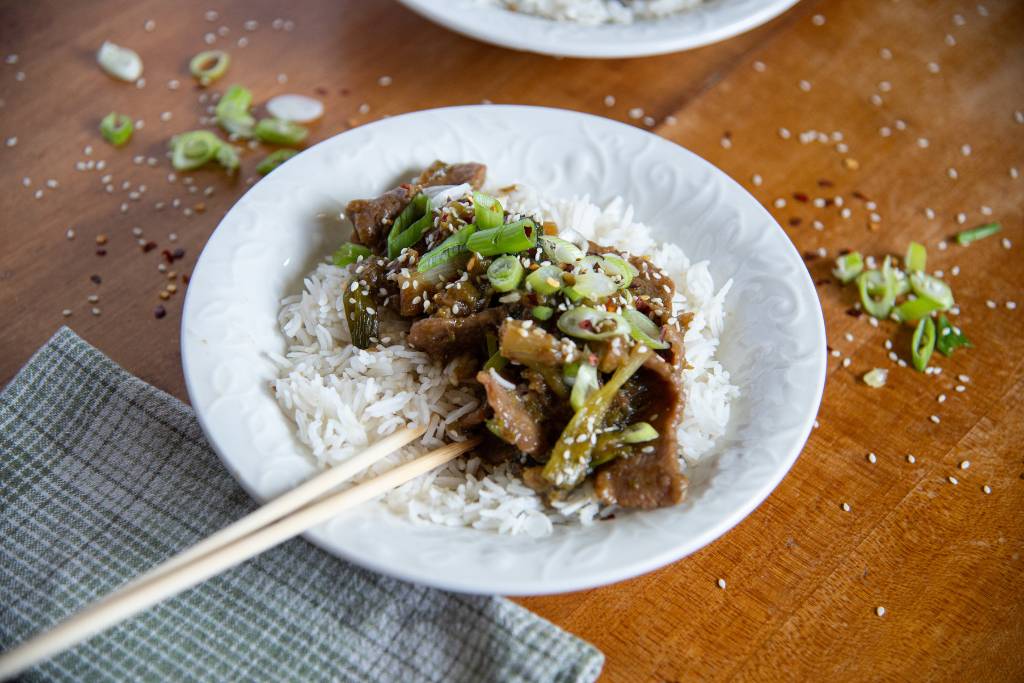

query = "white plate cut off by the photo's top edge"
[391,0,797,58]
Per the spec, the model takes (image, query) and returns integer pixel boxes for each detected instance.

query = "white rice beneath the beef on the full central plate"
[272,187,738,537]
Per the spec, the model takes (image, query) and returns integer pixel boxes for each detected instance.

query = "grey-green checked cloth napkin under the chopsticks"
[0,329,603,682]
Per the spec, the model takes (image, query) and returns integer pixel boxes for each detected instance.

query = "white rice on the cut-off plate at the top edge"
[476,0,703,26]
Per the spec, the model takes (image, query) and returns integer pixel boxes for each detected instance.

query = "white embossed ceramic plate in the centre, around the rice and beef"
[181,105,825,595]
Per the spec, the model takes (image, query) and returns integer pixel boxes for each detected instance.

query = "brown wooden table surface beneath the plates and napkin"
[0,0,1024,682]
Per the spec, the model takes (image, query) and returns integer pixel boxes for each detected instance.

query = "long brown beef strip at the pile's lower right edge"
[594,328,686,509]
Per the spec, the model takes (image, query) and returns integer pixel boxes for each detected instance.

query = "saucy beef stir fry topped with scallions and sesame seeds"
[335,162,685,508]
